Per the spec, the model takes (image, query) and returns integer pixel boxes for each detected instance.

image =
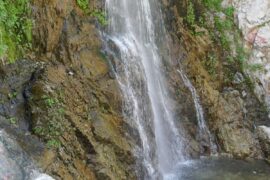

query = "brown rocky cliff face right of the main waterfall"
[160,1,268,158]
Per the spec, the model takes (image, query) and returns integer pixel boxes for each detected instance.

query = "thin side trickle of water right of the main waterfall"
[178,70,217,155]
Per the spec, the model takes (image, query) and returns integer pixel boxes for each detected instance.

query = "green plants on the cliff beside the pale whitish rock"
[184,0,262,84]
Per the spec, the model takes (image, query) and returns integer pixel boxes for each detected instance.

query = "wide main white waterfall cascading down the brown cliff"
[106,0,184,179]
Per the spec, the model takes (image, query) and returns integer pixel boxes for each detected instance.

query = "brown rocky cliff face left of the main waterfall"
[1,0,135,179]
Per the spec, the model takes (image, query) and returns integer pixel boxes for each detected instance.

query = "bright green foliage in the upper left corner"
[0,0,32,62]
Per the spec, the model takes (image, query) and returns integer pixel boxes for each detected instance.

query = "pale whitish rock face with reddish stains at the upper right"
[224,0,270,114]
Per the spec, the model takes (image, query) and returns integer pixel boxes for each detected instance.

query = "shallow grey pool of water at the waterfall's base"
[163,157,270,180]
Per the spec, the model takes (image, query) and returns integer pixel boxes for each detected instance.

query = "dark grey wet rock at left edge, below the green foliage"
[0,60,44,158]
